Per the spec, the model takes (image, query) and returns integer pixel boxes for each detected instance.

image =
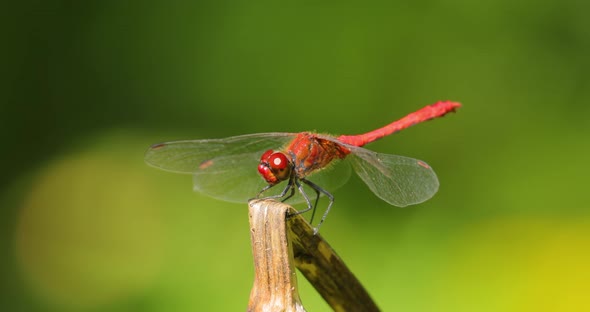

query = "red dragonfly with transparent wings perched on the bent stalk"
[145,101,461,234]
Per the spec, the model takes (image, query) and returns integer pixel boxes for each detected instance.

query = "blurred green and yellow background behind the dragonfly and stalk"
[0,0,590,311]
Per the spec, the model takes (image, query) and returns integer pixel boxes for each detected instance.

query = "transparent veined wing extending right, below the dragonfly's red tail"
[345,145,439,207]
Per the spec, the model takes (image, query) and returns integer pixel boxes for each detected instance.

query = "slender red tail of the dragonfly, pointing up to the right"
[338,101,461,146]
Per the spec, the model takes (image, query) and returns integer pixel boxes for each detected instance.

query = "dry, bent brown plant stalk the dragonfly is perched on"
[249,199,379,311]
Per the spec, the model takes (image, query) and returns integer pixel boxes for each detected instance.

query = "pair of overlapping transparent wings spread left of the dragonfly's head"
[145,133,295,202]
